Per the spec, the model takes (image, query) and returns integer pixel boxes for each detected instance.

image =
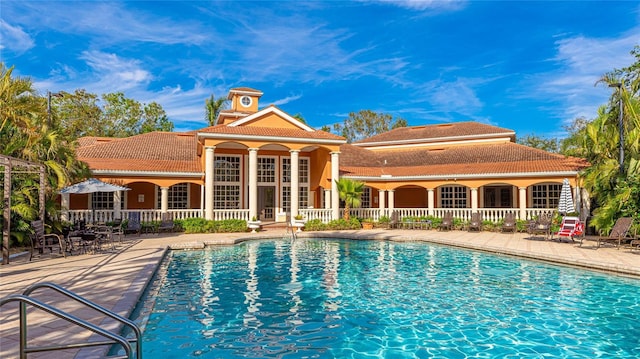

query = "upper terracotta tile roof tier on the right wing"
[355,121,514,144]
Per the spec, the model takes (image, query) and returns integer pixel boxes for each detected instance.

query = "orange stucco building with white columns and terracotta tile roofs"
[62,88,587,222]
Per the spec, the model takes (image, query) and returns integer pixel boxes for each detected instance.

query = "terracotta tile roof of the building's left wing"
[76,132,202,172]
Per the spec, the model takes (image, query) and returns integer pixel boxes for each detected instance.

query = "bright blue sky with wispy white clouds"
[0,0,640,138]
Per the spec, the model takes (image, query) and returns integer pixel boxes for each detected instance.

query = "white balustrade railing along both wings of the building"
[62,208,555,223]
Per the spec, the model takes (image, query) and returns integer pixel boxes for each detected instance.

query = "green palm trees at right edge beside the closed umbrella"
[576,46,640,231]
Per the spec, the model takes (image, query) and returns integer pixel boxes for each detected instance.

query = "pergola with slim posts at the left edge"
[0,155,45,264]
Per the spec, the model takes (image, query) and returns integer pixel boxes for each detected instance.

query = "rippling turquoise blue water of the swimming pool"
[135,239,640,358]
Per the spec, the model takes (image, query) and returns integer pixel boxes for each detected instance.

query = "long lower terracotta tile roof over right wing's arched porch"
[340,142,588,176]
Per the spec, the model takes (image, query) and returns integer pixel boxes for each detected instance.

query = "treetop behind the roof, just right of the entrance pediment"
[333,110,407,143]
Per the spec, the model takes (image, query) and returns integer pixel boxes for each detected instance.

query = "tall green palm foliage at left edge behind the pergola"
[0,64,89,246]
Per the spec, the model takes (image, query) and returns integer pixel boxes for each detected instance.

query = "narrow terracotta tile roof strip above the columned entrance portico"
[197,125,345,141]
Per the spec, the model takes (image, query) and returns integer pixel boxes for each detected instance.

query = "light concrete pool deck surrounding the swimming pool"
[0,229,640,358]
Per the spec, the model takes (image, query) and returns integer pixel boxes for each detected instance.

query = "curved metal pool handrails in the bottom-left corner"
[0,282,142,359]
